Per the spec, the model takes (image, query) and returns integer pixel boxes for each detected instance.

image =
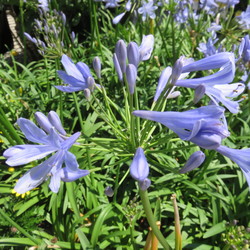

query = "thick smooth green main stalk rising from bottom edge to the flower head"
[140,190,170,250]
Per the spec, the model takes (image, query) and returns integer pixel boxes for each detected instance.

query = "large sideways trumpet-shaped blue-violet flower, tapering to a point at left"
[133,105,229,149]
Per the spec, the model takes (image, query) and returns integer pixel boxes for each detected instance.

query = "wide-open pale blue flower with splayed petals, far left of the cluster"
[3,111,89,194]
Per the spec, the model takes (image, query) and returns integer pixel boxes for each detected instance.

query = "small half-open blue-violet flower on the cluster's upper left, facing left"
[54,55,99,92]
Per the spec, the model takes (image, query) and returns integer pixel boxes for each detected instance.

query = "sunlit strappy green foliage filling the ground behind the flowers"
[0,0,250,249]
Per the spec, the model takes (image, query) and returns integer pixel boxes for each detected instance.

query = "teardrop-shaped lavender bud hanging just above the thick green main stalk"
[130,147,149,181]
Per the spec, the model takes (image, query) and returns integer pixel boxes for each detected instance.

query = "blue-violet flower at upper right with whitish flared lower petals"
[176,52,245,113]
